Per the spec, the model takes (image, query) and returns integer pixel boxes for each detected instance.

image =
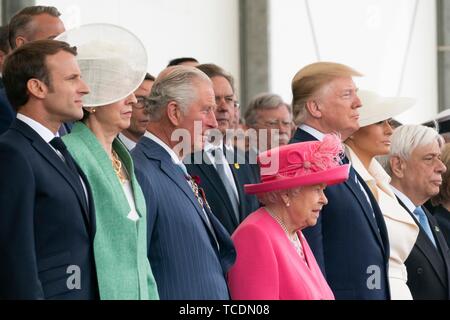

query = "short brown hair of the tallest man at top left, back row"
[9,6,61,49]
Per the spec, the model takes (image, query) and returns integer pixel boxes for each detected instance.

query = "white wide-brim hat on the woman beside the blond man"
[358,90,416,127]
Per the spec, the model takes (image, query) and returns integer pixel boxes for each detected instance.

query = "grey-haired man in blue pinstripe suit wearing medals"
[132,66,236,300]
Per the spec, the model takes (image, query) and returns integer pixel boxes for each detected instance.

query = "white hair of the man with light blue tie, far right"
[383,125,445,176]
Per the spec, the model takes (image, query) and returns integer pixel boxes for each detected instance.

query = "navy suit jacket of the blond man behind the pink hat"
[291,129,390,300]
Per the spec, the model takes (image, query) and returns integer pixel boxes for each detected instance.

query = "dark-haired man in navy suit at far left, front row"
[0,40,98,299]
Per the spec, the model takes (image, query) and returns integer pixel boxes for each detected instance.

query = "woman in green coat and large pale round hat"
[58,24,158,300]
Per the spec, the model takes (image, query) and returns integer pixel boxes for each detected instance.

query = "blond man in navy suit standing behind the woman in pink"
[291,62,390,299]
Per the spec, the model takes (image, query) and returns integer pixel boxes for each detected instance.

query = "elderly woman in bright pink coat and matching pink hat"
[228,135,349,300]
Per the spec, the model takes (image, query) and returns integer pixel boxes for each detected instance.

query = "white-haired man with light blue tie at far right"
[386,125,450,300]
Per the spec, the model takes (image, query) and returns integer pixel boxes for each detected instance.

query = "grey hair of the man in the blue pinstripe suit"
[145,65,211,121]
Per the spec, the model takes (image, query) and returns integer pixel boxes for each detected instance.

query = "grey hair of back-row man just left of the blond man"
[244,93,292,127]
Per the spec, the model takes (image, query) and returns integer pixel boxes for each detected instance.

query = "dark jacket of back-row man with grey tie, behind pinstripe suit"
[186,151,260,234]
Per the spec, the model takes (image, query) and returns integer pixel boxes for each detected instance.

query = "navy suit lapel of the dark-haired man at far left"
[14,120,90,225]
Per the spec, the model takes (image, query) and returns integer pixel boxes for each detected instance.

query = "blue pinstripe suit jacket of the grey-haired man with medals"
[132,137,236,300]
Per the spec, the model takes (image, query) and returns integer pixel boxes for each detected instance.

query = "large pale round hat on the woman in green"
[57,23,147,107]
